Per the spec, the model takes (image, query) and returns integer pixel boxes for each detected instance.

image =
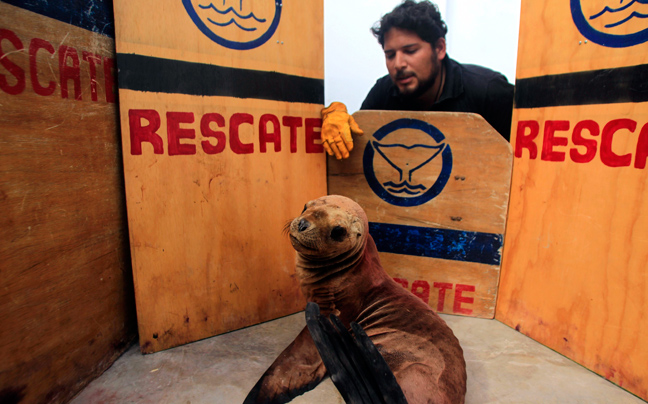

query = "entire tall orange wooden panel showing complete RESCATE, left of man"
[115,0,326,353]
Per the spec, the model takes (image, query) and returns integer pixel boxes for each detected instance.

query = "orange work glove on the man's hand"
[322,102,364,160]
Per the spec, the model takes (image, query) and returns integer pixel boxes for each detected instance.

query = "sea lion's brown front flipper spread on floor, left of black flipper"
[243,327,326,404]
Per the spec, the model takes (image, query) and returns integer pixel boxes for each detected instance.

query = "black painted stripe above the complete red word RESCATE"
[117,53,324,104]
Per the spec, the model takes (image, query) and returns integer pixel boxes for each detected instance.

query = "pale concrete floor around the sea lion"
[71,313,644,404]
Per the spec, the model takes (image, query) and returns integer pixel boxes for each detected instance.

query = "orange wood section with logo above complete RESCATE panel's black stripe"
[115,0,324,78]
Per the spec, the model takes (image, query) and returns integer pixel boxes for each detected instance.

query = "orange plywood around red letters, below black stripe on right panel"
[497,105,648,397]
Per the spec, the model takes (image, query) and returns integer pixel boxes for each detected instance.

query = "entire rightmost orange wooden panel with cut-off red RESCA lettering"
[496,0,648,399]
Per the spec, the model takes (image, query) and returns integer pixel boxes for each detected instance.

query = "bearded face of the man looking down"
[383,27,445,98]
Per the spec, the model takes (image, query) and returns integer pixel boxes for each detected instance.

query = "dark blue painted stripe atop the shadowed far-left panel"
[2,0,115,38]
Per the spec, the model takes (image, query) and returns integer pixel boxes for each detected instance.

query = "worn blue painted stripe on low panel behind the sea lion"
[369,222,504,265]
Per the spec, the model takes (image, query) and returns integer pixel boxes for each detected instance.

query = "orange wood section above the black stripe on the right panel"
[516,0,648,79]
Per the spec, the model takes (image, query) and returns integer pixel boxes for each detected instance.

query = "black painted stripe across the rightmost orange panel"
[515,65,648,108]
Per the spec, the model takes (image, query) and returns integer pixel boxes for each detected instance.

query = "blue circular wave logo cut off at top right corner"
[570,0,648,48]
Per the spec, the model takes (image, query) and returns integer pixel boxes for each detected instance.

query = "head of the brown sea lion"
[288,195,369,267]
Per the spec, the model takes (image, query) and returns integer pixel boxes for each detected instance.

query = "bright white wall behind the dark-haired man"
[324,0,521,112]
